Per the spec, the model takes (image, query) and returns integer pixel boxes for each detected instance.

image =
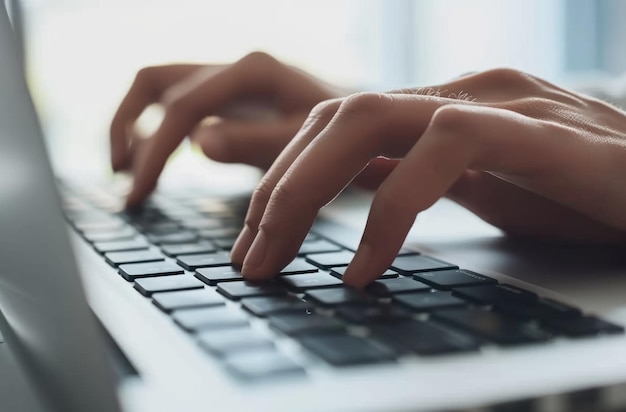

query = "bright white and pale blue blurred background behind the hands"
[8,0,626,179]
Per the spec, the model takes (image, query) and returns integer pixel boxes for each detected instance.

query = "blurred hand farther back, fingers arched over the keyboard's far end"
[111,52,341,206]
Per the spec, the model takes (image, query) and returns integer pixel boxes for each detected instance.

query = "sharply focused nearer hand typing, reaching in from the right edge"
[231,69,626,287]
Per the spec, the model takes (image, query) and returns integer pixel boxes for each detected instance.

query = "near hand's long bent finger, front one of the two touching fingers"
[237,93,470,279]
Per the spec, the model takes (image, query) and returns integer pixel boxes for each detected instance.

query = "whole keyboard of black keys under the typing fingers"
[61,185,624,380]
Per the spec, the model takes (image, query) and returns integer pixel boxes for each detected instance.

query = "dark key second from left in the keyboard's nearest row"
[299,335,395,366]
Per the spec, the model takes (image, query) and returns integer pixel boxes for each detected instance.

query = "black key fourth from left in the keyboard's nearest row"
[432,308,549,345]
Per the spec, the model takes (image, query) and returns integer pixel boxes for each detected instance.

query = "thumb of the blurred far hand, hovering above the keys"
[191,114,306,169]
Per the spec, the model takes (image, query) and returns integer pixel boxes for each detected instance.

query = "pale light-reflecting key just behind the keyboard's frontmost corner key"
[198,327,274,356]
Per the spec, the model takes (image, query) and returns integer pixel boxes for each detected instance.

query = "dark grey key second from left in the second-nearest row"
[267,313,345,336]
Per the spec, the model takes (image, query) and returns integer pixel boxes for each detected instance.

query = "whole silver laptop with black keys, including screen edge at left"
[0,4,626,412]
